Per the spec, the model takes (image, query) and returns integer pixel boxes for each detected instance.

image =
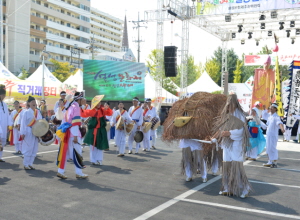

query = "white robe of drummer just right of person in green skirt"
[112,110,131,154]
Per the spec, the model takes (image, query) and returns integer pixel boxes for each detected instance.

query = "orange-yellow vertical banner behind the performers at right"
[251,69,275,107]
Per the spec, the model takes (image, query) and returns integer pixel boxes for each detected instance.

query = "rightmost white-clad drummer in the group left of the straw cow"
[143,99,157,151]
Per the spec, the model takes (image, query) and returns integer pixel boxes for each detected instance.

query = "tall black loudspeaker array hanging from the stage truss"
[164,46,177,77]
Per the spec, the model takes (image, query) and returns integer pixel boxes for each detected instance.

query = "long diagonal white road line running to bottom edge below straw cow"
[134,176,221,220]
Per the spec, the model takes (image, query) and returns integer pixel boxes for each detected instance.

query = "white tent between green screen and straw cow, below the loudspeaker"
[145,74,179,103]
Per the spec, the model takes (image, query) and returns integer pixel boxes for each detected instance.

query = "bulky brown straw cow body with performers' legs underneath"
[162,92,226,182]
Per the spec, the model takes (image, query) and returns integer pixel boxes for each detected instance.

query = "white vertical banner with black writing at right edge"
[286,61,300,127]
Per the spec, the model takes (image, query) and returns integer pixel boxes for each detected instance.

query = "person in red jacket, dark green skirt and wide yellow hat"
[81,95,113,166]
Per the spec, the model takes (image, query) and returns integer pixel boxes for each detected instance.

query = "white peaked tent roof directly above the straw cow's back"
[187,72,221,96]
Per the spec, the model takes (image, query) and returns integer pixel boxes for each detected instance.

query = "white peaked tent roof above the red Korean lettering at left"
[27,64,61,85]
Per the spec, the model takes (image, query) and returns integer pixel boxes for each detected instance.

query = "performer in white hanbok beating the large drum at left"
[20,96,42,170]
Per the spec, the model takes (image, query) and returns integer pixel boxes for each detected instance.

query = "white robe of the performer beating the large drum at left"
[20,108,42,167]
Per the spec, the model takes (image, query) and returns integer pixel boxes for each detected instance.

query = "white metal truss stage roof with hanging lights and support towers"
[144,0,300,109]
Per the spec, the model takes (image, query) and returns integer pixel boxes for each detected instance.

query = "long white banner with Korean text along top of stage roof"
[197,0,300,15]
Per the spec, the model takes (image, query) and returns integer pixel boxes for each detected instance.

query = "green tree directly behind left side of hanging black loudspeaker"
[146,49,177,95]
